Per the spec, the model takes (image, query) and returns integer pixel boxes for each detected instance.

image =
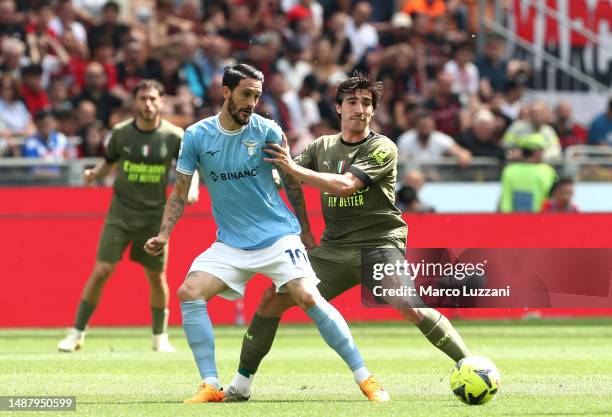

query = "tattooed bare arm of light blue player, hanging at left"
[144,172,193,256]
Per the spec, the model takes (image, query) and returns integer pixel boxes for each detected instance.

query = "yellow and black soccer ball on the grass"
[451,356,500,405]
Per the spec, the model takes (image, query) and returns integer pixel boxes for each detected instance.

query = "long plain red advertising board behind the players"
[0,188,612,327]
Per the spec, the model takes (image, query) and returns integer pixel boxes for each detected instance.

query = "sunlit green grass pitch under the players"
[0,319,612,417]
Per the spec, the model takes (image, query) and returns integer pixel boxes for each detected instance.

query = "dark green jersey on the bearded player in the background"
[105,119,183,215]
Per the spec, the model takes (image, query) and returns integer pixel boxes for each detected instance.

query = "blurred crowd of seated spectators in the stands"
[0,0,612,210]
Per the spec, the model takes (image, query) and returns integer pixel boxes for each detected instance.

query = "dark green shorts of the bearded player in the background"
[96,214,168,272]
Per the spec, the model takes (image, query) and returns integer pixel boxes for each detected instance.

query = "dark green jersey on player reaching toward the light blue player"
[296,132,408,249]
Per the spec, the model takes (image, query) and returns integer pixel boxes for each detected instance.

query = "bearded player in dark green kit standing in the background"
[57,80,199,352]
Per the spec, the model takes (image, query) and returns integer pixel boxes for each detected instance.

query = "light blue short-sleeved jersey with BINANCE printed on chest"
[176,114,301,249]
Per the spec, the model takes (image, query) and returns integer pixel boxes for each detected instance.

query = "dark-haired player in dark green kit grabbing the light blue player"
[224,75,469,402]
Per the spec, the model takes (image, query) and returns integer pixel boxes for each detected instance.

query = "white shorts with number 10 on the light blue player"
[189,235,319,300]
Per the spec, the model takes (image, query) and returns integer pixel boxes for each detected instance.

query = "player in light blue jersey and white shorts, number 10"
[145,64,389,403]
